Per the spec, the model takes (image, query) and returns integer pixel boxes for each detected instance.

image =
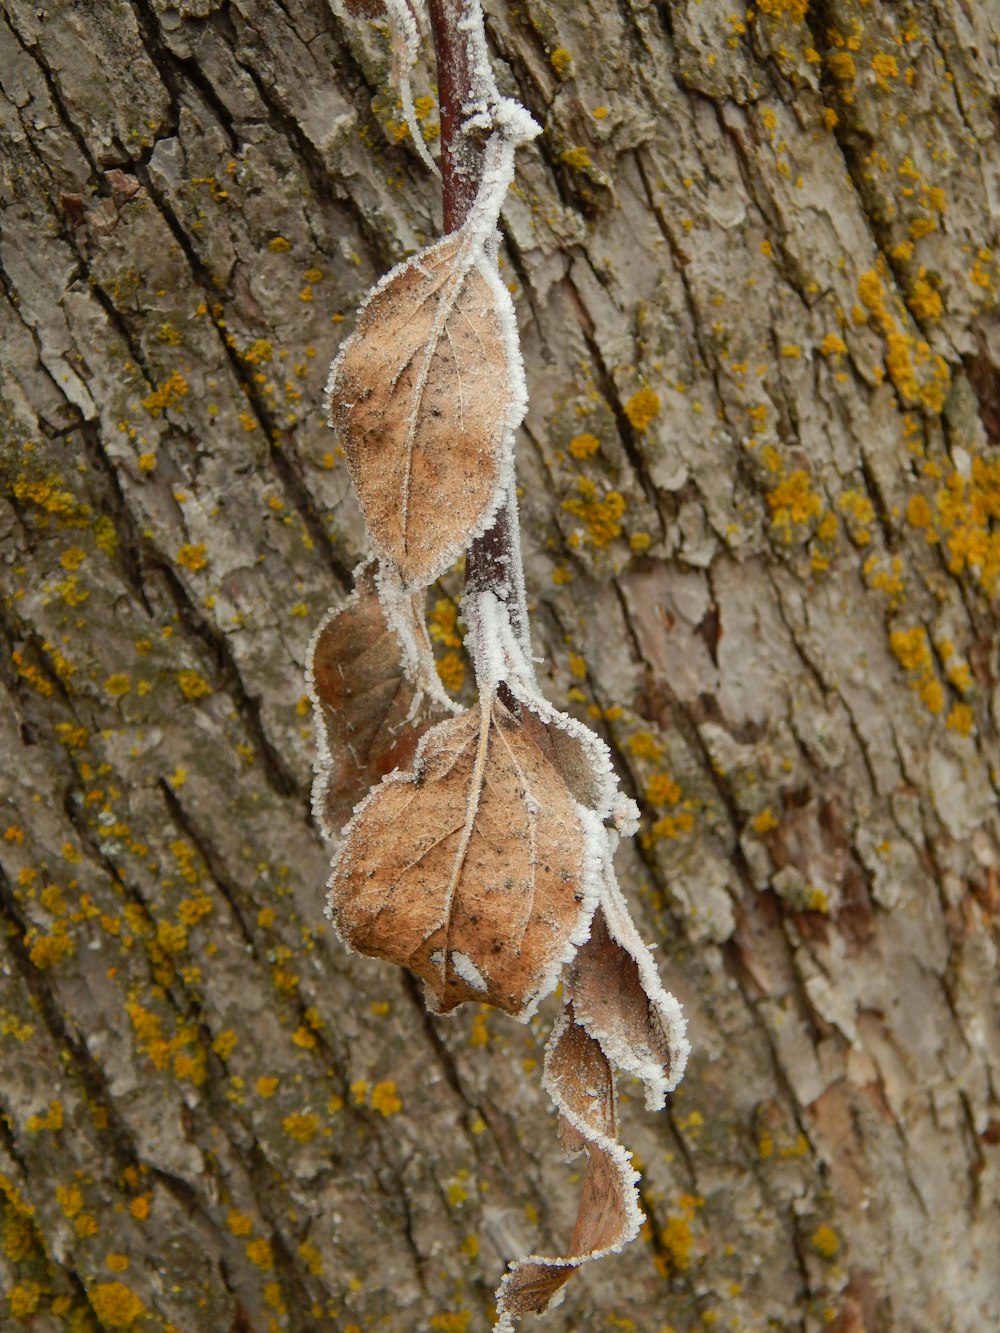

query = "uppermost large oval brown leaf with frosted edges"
[327,232,524,588]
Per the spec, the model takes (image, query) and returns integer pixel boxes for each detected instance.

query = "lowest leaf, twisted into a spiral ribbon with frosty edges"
[496,1001,643,1333]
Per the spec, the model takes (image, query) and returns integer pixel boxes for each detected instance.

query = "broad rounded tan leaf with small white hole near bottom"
[329,698,595,1017]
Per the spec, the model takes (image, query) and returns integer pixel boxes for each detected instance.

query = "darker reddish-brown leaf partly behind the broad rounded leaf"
[307,561,448,837]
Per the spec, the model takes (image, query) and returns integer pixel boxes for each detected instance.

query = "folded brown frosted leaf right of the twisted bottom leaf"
[576,868,691,1110]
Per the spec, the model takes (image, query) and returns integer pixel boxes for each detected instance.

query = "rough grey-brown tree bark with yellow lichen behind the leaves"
[0,0,1000,1333]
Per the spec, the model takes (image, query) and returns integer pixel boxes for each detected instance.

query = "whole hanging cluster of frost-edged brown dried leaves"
[308,12,688,1333]
